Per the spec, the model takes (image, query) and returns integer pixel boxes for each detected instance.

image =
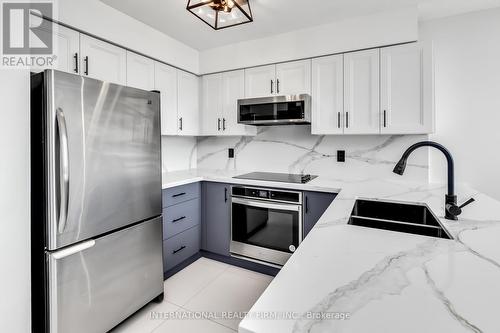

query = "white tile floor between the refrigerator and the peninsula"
[113,258,272,333]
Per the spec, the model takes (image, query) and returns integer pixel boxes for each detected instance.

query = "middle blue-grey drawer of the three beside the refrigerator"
[163,198,201,239]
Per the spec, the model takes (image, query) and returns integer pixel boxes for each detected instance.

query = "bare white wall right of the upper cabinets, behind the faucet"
[420,9,500,199]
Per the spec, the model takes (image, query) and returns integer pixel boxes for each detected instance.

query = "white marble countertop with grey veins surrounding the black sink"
[163,170,500,333]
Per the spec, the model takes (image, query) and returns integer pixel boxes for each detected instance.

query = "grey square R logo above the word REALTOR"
[2,2,53,55]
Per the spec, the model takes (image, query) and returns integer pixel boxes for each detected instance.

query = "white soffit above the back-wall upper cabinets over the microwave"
[200,6,418,73]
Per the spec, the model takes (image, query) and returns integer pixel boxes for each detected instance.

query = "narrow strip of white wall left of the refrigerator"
[0,69,31,332]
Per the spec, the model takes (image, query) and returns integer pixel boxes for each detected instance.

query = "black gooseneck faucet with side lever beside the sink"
[393,141,474,221]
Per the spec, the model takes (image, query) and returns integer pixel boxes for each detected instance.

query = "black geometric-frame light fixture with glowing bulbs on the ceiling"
[186,0,253,30]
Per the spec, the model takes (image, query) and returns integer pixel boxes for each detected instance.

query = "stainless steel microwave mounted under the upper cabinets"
[238,94,311,126]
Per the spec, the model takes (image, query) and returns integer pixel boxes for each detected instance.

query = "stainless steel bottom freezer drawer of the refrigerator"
[47,217,163,333]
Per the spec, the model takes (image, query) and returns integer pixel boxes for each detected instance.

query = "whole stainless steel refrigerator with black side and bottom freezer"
[31,70,163,333]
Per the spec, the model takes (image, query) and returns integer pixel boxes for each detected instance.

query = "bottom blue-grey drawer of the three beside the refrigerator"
[163,226,201,271]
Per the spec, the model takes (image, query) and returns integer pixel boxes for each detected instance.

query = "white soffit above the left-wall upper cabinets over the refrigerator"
[56,0,199,73]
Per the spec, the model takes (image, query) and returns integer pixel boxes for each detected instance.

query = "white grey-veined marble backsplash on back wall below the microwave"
[195,125,429,181]
